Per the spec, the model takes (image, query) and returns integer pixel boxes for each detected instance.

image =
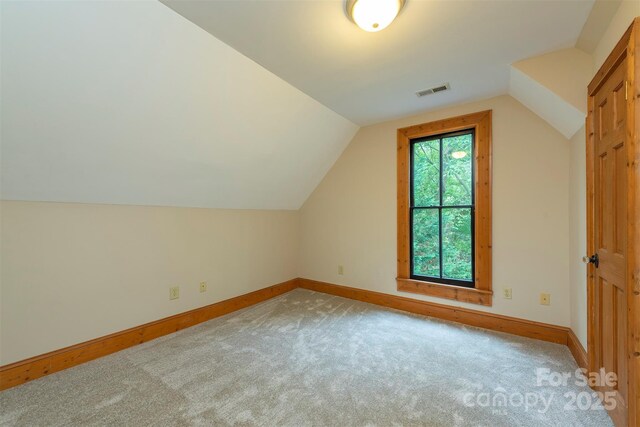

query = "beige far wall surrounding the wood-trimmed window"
[299,96,570,326]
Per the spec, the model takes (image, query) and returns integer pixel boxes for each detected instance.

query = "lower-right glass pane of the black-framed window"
[442,208,473,280]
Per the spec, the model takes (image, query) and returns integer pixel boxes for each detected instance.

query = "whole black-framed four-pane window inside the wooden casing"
[409,129,475,288]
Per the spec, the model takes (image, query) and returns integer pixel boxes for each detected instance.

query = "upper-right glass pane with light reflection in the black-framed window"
[442,134,473,206]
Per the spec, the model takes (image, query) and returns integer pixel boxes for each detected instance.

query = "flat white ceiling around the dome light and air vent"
[161,0,593,125]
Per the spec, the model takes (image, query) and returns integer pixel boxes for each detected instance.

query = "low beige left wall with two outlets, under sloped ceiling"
[0,201,298,364]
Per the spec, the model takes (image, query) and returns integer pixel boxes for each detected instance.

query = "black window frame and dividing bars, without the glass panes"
[409,128,476,288]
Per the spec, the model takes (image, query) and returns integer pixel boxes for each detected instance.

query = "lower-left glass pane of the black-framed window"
[412,209,440,277]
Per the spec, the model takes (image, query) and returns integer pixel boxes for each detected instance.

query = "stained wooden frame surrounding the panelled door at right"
[585,17,640,426]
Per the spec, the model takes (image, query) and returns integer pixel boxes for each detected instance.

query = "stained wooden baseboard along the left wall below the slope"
[0,279,298,390]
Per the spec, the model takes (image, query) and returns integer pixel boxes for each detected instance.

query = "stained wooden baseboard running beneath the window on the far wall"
[298,279,569,345]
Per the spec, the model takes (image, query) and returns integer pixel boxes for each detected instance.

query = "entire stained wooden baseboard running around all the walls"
[0,278,587,390]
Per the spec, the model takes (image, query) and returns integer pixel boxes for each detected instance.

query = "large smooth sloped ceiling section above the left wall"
[1,0,357,209]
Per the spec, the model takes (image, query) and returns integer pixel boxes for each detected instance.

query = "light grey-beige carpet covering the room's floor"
[0,289,612,427]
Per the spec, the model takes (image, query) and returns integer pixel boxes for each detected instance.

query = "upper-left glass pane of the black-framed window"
[412,139,440,206]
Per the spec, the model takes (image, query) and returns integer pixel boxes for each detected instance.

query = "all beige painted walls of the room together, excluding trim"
[0,6,640,364]
